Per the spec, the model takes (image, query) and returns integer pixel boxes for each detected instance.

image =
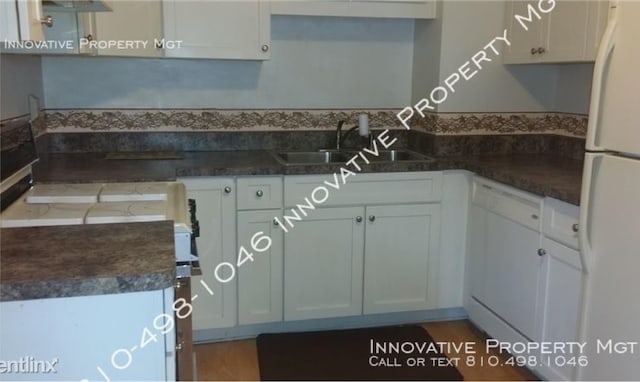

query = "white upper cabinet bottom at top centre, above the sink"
[271,0,436,19]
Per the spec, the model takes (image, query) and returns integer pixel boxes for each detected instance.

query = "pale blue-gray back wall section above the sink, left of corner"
[43,16,414,109]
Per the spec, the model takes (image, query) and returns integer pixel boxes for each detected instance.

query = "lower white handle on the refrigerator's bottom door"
[578,153,604,274]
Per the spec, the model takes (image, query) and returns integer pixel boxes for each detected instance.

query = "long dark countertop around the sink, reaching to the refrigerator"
[34,150,582,205]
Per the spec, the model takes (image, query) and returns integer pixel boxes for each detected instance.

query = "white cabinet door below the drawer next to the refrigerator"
[535,238,582,380]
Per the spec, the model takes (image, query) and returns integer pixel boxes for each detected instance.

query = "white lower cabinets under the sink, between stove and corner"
[185,172,460,341]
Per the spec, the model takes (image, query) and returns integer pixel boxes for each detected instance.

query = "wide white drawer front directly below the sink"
[284,172,442,207]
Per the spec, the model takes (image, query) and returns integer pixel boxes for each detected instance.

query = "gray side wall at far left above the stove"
[0,54,44,119]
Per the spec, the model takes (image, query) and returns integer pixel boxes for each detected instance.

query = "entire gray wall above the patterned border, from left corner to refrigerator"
[38,10,593,114]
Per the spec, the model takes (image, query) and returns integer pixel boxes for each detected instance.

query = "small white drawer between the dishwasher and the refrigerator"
[542,198,579,249]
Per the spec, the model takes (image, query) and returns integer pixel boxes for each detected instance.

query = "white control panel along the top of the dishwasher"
[472,177,542,231]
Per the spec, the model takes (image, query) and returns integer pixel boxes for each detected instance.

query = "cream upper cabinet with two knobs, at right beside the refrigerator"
[503,0,608,64]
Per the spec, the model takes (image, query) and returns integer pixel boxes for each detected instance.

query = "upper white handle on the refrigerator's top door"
[586,6,618,151]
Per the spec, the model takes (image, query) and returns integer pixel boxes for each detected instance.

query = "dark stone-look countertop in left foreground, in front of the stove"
[0,221,175,301]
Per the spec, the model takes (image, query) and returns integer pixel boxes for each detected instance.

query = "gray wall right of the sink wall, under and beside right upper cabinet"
[412,1,593,114]
